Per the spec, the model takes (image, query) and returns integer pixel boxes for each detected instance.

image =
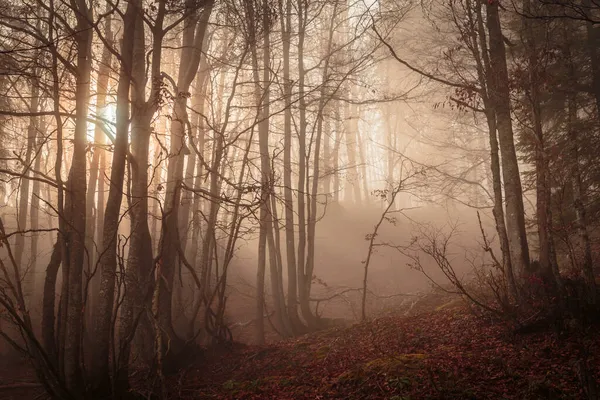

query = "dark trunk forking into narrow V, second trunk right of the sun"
[117,7,159,389]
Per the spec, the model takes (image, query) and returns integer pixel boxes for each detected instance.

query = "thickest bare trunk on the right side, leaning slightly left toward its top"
[486,0,529,283]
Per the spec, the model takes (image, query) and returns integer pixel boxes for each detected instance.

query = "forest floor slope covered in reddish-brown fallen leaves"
[169,307,600,400]
